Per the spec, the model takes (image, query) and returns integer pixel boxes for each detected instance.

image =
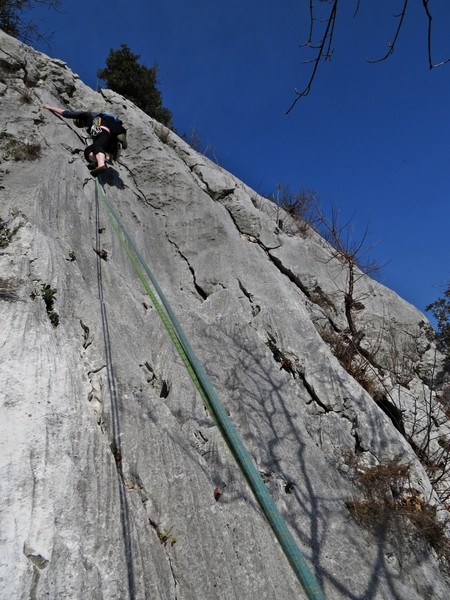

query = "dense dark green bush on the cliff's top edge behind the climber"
[97,44,172,127]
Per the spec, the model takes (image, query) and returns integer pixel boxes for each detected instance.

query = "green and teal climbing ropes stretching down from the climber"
[95,180,325,600]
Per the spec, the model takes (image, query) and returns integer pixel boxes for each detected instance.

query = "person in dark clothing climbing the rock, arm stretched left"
[42,104,126,177]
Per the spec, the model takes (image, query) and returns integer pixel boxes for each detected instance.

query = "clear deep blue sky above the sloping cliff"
[25,0,450,324]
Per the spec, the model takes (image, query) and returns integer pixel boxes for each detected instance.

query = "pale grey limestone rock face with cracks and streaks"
[0,33,450,600]
